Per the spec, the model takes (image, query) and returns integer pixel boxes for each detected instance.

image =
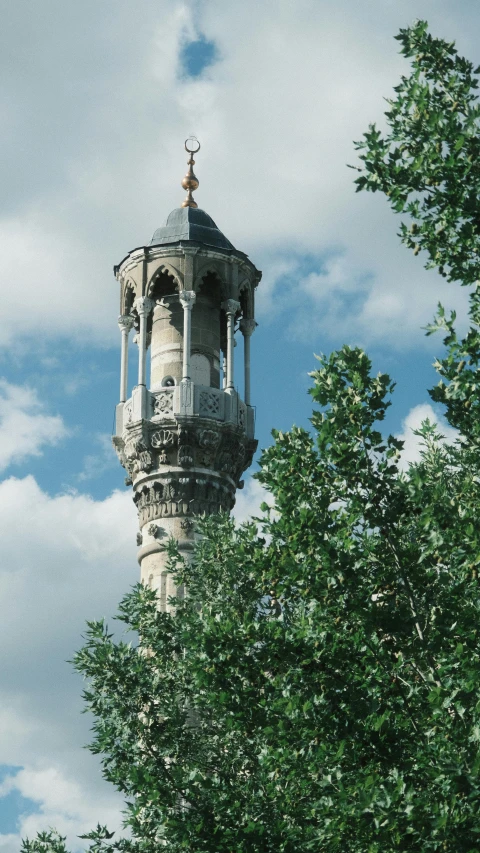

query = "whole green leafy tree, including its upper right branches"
[23,22,480,853]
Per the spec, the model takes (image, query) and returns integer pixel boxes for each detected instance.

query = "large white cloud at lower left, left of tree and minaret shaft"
[0,477,139,853]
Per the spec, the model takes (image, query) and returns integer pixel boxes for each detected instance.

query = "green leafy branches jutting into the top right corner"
[356,16,480,284]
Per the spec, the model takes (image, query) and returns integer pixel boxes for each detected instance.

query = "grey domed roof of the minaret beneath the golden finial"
[150,207,235,249]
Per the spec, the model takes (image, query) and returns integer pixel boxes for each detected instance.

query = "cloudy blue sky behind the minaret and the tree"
[0,0,480,853]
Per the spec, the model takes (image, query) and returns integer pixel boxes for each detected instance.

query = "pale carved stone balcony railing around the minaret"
[116,380,255,439]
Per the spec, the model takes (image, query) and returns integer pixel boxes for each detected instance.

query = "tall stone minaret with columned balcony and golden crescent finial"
[113,137,261,609]
